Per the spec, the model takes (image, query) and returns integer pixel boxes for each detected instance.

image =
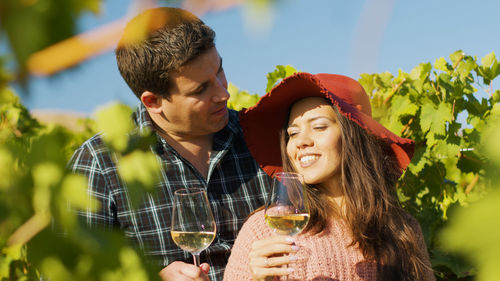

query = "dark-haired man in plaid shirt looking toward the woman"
[71,8,269,280]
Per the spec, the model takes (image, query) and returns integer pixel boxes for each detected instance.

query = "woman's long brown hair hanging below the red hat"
[281,103,430,281]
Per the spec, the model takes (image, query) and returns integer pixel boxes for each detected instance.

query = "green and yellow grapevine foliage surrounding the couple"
[0,0,500,280]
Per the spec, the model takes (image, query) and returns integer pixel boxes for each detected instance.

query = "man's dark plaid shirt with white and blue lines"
[70,104,270,280]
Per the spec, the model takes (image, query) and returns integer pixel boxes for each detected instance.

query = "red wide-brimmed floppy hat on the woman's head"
[240,72,415,176]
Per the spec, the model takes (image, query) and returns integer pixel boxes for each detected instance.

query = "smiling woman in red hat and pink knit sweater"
[224,73,435,280]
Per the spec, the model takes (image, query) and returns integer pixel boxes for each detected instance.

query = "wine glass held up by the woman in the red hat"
[265,172,309,281]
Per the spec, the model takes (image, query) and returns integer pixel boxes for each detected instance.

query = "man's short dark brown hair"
[115,7,215,98]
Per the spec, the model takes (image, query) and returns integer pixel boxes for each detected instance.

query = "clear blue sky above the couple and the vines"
[15,0,500,114]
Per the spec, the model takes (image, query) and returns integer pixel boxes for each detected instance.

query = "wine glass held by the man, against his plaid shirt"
[170,188,216,266]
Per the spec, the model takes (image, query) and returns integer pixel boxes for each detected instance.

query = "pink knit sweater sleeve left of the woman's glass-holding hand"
[224,211,270,281]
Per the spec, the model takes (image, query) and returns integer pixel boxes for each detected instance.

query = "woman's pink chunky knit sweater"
[224,210,435,281]
